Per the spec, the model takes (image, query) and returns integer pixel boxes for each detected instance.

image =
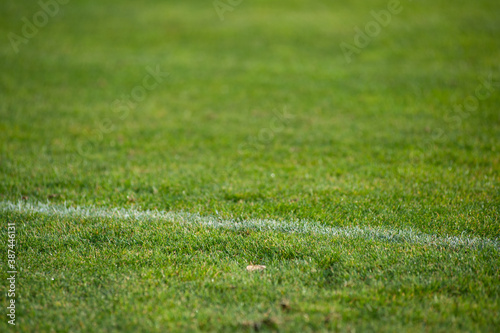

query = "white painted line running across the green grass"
[0,201,500,250]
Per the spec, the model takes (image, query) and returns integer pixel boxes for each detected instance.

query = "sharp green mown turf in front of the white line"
[2,209,500,332]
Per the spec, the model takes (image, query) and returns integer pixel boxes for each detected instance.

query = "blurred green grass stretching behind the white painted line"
[0,0,500,237]
